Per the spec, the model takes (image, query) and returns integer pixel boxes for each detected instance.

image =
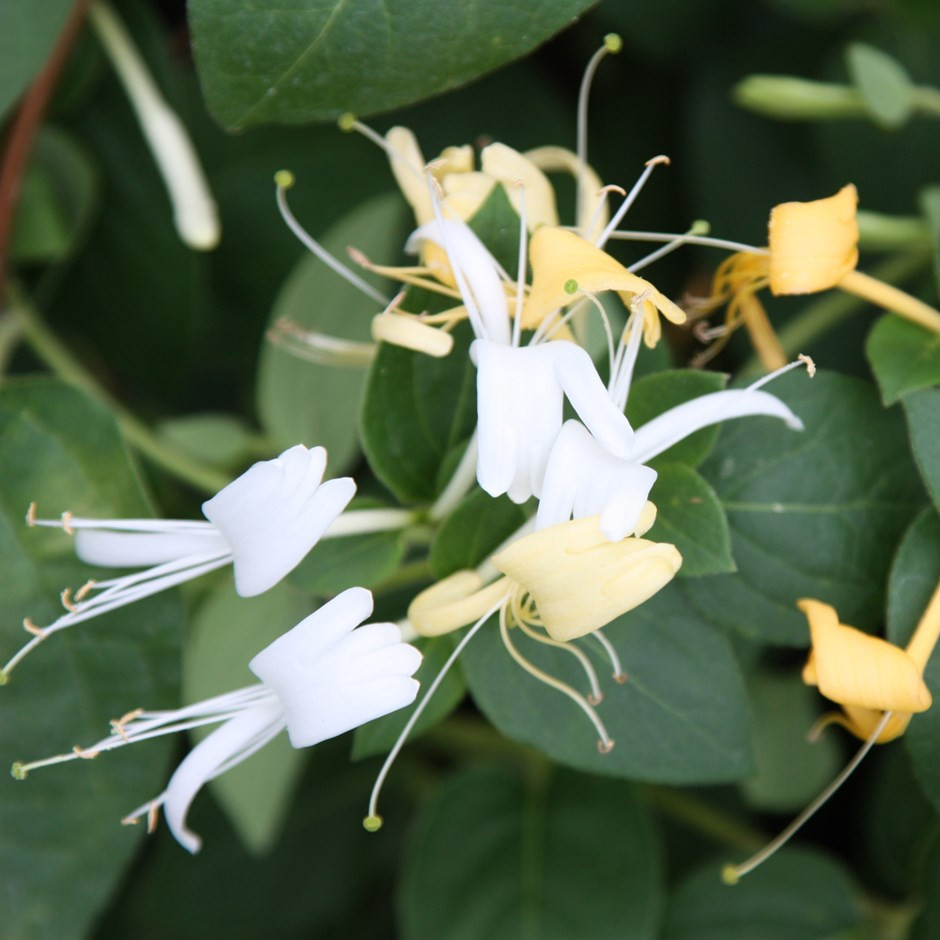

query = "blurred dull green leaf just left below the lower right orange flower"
[743,669,842,813]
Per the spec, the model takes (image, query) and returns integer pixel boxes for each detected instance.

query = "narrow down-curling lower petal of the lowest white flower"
[163,700,284,854]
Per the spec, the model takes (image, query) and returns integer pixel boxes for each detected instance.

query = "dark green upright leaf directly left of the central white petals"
[360,324,477,502]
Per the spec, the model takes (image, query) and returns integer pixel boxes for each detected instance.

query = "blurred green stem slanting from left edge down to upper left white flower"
[6,284,229,493]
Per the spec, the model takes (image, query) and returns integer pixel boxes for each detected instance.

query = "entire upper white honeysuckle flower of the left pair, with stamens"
[0,444,358,684]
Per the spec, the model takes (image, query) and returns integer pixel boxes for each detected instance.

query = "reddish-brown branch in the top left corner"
[0,0,92,298]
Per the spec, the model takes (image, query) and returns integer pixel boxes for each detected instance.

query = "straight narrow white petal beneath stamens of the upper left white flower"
[75,522,228,568]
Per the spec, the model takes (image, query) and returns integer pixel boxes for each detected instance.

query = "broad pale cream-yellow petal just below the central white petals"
[493,516,682,642]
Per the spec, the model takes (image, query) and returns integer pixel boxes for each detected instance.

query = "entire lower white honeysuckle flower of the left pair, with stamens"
[13,587,421,853]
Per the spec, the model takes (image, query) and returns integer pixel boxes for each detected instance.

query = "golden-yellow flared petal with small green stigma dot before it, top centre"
[522,227,686,347]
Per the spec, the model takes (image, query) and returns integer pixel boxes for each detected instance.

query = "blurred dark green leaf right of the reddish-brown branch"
[10,127,98,264]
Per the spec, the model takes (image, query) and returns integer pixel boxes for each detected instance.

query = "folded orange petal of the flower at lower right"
[797,598,931,716]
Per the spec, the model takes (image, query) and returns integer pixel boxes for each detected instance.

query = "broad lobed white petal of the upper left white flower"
[202,444,356,597]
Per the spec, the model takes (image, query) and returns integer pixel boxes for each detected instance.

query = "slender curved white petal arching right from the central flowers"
[633,389,803,463]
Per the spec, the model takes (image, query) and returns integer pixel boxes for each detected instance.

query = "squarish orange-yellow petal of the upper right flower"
[769,183,858,294]
